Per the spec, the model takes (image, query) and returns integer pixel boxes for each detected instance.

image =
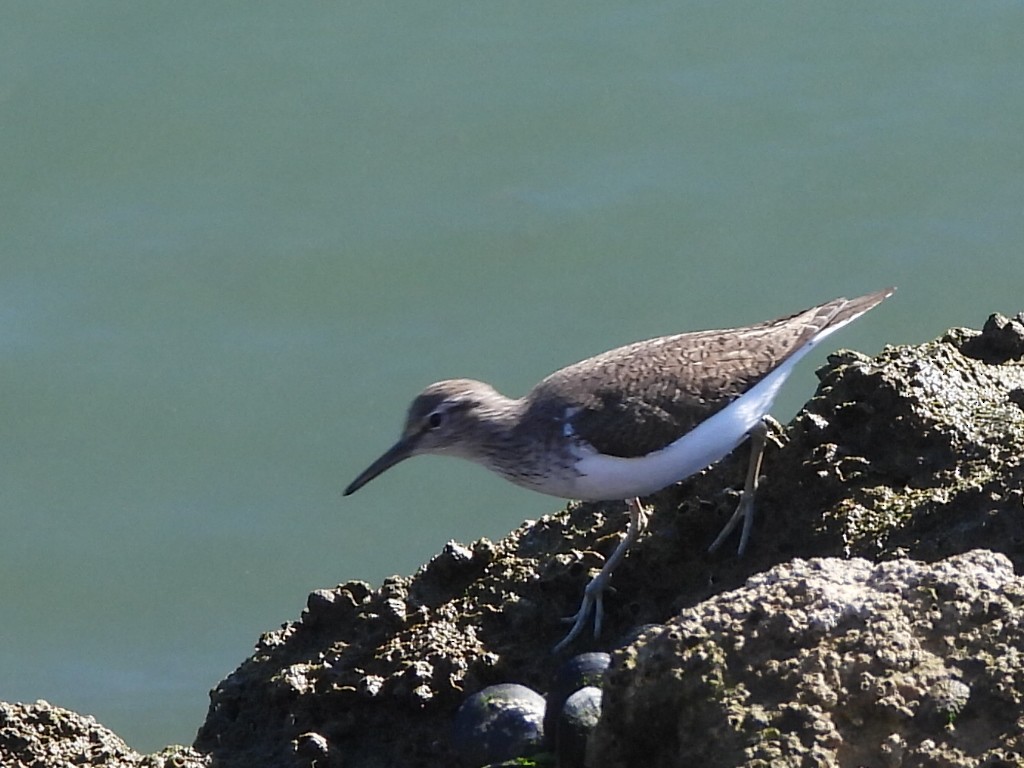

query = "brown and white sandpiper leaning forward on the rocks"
[345,288,895,651]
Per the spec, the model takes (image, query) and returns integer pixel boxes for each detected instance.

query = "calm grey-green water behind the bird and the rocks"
[0,0,1024,750]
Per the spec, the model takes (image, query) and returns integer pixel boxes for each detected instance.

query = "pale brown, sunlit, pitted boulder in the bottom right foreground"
[590,551,1024,768]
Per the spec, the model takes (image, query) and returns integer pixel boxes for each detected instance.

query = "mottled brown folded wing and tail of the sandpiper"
[527,290,892,457]
